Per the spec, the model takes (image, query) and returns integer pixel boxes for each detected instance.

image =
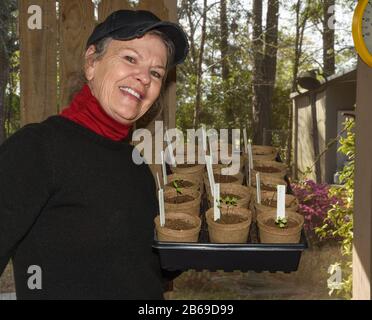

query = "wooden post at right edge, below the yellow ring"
[353,60,372,300]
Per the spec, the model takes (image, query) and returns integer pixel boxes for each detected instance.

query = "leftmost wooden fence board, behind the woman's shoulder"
[18,0,57,126]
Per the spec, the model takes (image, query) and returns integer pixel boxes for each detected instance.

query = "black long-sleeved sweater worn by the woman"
[0,116,163,299]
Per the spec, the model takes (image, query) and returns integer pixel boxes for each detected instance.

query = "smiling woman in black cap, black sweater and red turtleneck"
[0,10,188,299]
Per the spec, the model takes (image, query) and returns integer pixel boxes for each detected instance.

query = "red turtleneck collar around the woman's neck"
[60,84,131,141]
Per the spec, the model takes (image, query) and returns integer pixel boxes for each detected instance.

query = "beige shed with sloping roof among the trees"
[291,68,357,184]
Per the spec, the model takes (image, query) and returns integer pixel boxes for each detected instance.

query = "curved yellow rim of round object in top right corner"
[352,0,372,67]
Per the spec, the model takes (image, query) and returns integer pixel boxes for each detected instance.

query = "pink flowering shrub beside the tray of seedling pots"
[291,180,340,240]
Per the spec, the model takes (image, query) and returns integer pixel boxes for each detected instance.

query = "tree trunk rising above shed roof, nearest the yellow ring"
[323,0,336,77]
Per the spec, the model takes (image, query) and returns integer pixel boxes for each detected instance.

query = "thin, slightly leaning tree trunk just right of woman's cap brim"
[194,0,207,129]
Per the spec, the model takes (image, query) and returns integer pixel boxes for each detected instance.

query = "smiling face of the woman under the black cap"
[86,34,167,125]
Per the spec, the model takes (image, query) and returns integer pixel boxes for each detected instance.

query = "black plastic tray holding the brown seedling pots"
[153,222,307,272]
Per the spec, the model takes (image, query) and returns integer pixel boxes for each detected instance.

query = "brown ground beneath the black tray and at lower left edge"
[0,244,341,300]
